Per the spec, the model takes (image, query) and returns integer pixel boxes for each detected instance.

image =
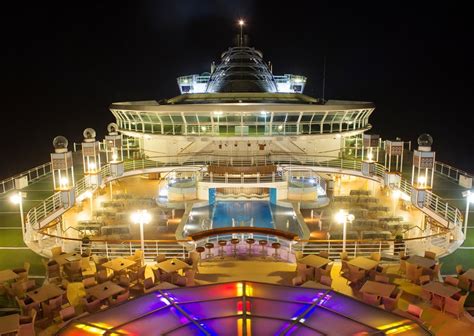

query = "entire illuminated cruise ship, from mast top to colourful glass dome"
[0,33,474,336]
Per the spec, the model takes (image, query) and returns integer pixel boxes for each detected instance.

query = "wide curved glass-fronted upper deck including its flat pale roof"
[110,93,375,138]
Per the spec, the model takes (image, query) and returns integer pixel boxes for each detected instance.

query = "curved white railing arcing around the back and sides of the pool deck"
[26,154,463,258]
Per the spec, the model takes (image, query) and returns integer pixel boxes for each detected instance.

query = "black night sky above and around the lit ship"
[0,0,474,178]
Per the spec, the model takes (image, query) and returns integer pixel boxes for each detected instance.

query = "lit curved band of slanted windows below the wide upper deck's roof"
[111,104,373,137]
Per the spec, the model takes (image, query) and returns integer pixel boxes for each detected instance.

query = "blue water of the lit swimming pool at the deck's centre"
[212,201,274,228]
